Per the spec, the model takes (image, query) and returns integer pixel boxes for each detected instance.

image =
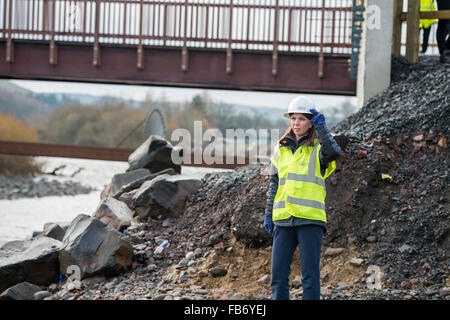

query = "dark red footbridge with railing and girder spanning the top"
[0,0,356,95]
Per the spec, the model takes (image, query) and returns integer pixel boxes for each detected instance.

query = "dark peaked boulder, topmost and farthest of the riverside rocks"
[127,135,181,173]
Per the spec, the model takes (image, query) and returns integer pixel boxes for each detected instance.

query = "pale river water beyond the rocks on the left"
[0,157,229,246]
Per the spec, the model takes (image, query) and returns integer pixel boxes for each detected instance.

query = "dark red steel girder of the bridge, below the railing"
[0,40,356,95]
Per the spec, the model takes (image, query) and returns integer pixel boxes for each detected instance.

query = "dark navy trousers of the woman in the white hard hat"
[271,225,323,300]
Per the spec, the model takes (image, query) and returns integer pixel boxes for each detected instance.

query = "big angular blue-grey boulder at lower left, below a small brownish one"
[59,214,133,279]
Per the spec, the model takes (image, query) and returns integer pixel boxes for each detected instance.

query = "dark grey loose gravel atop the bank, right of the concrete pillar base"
[333,56,450,141]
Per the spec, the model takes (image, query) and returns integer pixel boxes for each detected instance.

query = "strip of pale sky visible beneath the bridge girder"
[11,80,356,111]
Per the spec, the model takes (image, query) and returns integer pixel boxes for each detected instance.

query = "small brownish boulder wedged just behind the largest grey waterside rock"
[93,198,134,231]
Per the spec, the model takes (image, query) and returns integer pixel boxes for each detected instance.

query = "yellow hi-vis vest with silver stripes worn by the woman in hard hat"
[271,139,336,222]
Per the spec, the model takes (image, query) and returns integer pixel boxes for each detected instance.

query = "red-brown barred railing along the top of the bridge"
[0,0,352,55]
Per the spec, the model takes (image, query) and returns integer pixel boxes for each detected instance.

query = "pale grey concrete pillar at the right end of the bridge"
[356,0,394,108]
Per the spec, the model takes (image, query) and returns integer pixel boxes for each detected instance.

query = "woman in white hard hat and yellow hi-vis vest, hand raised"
[264,96,341,300]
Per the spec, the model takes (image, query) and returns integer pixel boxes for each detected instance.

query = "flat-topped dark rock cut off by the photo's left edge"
[0,237,62,292]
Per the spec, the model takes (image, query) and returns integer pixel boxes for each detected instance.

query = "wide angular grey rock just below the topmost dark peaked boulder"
[130,175,201,217]
